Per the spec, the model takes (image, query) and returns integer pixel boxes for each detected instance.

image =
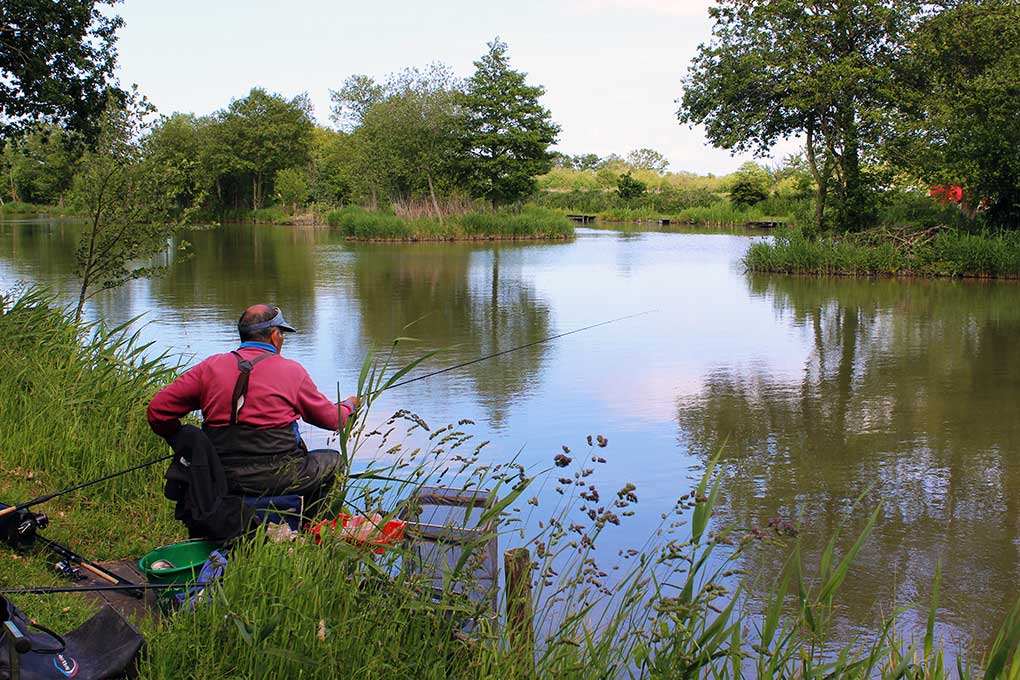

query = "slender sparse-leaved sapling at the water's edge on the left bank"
[70,94,196,319]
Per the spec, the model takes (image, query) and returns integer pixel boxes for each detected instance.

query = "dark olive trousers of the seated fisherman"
[220,449,343,519]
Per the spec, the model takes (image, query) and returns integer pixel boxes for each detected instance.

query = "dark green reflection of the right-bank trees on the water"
[678,276,1020,652]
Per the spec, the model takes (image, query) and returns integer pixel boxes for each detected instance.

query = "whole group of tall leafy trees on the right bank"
[678,0,1020,230]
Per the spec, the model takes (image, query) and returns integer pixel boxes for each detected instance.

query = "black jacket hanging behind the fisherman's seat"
[163,425,254,541]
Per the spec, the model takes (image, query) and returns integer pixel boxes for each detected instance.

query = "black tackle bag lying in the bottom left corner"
[0,596,145,680]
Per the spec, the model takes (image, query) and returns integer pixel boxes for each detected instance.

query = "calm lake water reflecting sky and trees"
[0,220,1020,652]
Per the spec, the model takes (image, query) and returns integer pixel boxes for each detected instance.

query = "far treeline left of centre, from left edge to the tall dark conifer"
[2,39,559,219]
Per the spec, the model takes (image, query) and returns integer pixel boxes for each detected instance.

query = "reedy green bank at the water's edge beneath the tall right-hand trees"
[744,227,1020,278]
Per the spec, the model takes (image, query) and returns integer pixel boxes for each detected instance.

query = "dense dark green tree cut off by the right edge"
[889,0,1020,228]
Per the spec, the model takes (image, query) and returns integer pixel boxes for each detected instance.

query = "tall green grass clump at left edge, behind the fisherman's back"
[0,289,174,499]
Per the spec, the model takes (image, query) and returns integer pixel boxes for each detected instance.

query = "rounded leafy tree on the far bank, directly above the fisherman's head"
[216,88,314,209]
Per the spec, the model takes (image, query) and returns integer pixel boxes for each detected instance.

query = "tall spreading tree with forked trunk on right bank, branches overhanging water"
[677,0,919,229]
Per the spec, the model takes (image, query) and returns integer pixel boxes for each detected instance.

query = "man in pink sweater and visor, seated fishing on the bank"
[147,305,358,513]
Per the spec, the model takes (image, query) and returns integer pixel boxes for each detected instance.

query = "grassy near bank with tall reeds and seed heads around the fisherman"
[0,293,1020,679]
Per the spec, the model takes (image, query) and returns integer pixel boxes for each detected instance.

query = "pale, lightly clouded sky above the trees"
[109,0,779,174]
